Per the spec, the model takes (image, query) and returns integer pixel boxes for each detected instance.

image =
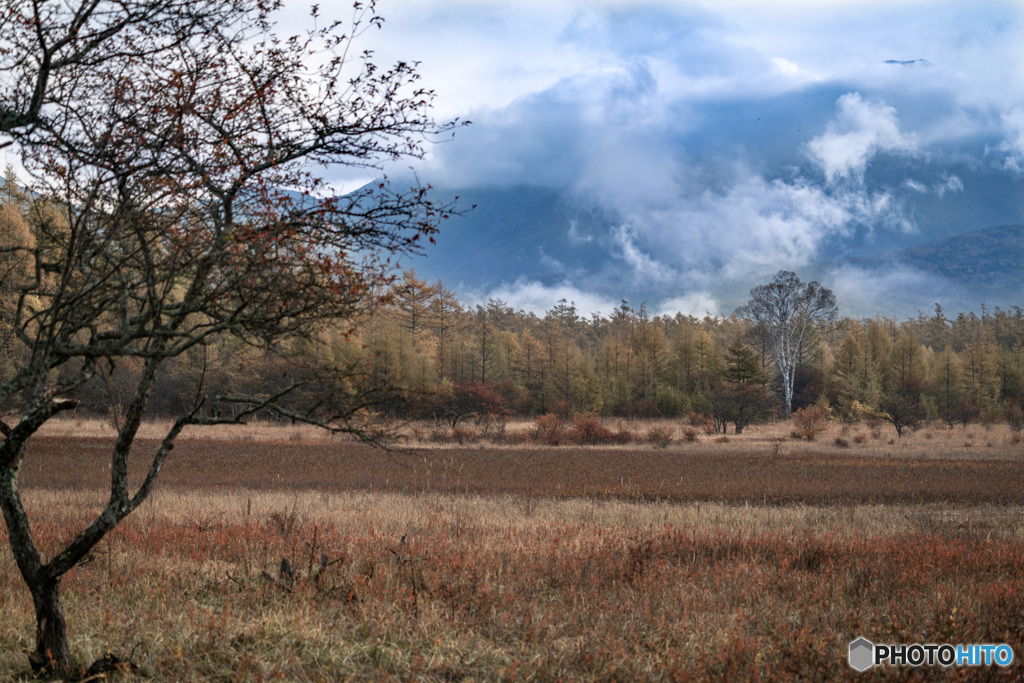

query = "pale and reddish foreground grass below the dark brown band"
[0,494,1024,681]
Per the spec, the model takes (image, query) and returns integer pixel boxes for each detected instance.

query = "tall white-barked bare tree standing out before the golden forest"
[736,270,837,419]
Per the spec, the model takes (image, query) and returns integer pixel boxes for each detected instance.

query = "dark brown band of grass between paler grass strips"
[23,435,1024,505]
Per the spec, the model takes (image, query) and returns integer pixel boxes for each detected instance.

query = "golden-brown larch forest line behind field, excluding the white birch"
[0,172,1024,430]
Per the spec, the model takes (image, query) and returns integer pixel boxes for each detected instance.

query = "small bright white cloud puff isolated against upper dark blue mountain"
[807,92,919,182]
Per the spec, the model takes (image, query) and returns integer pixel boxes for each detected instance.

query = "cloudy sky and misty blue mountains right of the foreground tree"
[313,0,1024,316]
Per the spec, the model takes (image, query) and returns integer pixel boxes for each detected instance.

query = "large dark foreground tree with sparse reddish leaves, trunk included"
[0,0,454,676]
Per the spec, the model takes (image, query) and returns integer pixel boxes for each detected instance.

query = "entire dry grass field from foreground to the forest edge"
[0,421,1024,681]
